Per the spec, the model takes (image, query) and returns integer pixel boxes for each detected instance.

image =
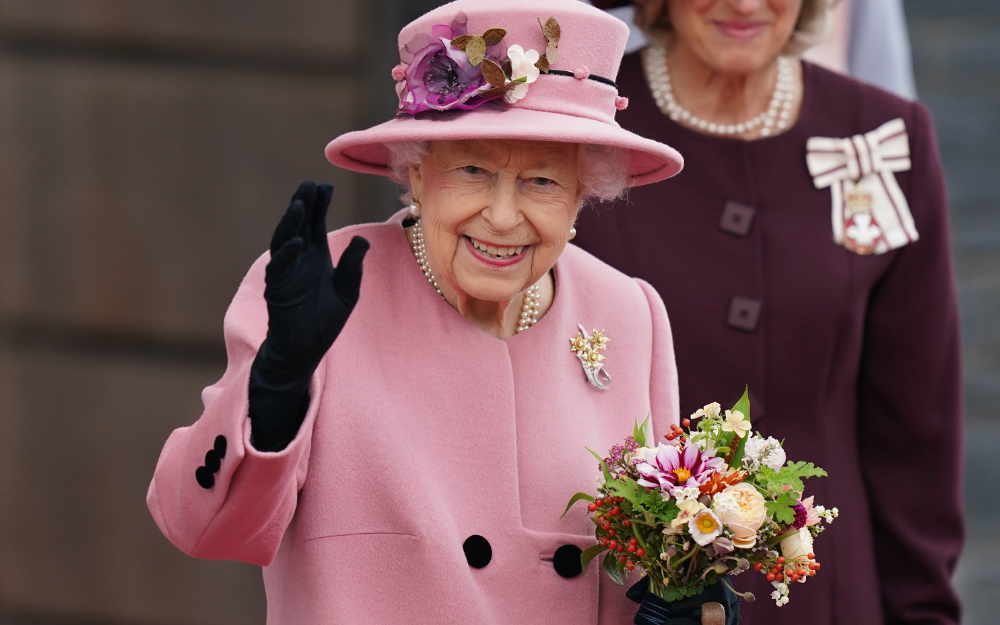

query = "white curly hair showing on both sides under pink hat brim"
[386,141,629,206]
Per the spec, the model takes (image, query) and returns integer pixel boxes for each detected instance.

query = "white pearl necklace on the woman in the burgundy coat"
[646,46,795,137]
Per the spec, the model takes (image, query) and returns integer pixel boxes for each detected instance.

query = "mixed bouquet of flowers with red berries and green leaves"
[564,392,838,606]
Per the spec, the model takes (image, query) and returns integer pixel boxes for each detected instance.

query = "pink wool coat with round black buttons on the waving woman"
[147,214,680,625]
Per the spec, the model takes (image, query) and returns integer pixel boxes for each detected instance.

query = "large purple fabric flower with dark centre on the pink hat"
[396,13,508,115]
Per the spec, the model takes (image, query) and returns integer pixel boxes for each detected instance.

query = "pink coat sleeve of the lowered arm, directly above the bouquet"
[635,278,680,441]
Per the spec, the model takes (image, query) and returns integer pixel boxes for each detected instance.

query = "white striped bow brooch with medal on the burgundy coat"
[806,118,919,256]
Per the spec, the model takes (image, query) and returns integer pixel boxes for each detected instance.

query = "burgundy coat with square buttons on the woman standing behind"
[574,54,963,625]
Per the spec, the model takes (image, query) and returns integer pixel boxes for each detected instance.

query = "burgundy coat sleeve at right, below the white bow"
[858,104,964,625]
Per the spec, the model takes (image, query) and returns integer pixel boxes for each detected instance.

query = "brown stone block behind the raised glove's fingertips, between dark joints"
[0,55,360,343]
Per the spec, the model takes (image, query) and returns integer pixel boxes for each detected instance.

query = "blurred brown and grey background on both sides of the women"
[0,0,1000,625]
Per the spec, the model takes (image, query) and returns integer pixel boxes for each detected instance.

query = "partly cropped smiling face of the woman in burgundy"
[665,0,803,74]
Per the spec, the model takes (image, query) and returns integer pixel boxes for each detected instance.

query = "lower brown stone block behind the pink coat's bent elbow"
[0,343,265,625]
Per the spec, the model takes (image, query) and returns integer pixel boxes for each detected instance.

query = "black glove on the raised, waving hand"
[250,181,368,451]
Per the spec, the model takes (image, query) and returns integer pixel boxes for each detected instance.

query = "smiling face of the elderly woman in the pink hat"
[410,140,582,310]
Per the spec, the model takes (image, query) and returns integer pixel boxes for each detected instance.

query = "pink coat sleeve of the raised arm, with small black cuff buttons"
[146,254,323,565]
